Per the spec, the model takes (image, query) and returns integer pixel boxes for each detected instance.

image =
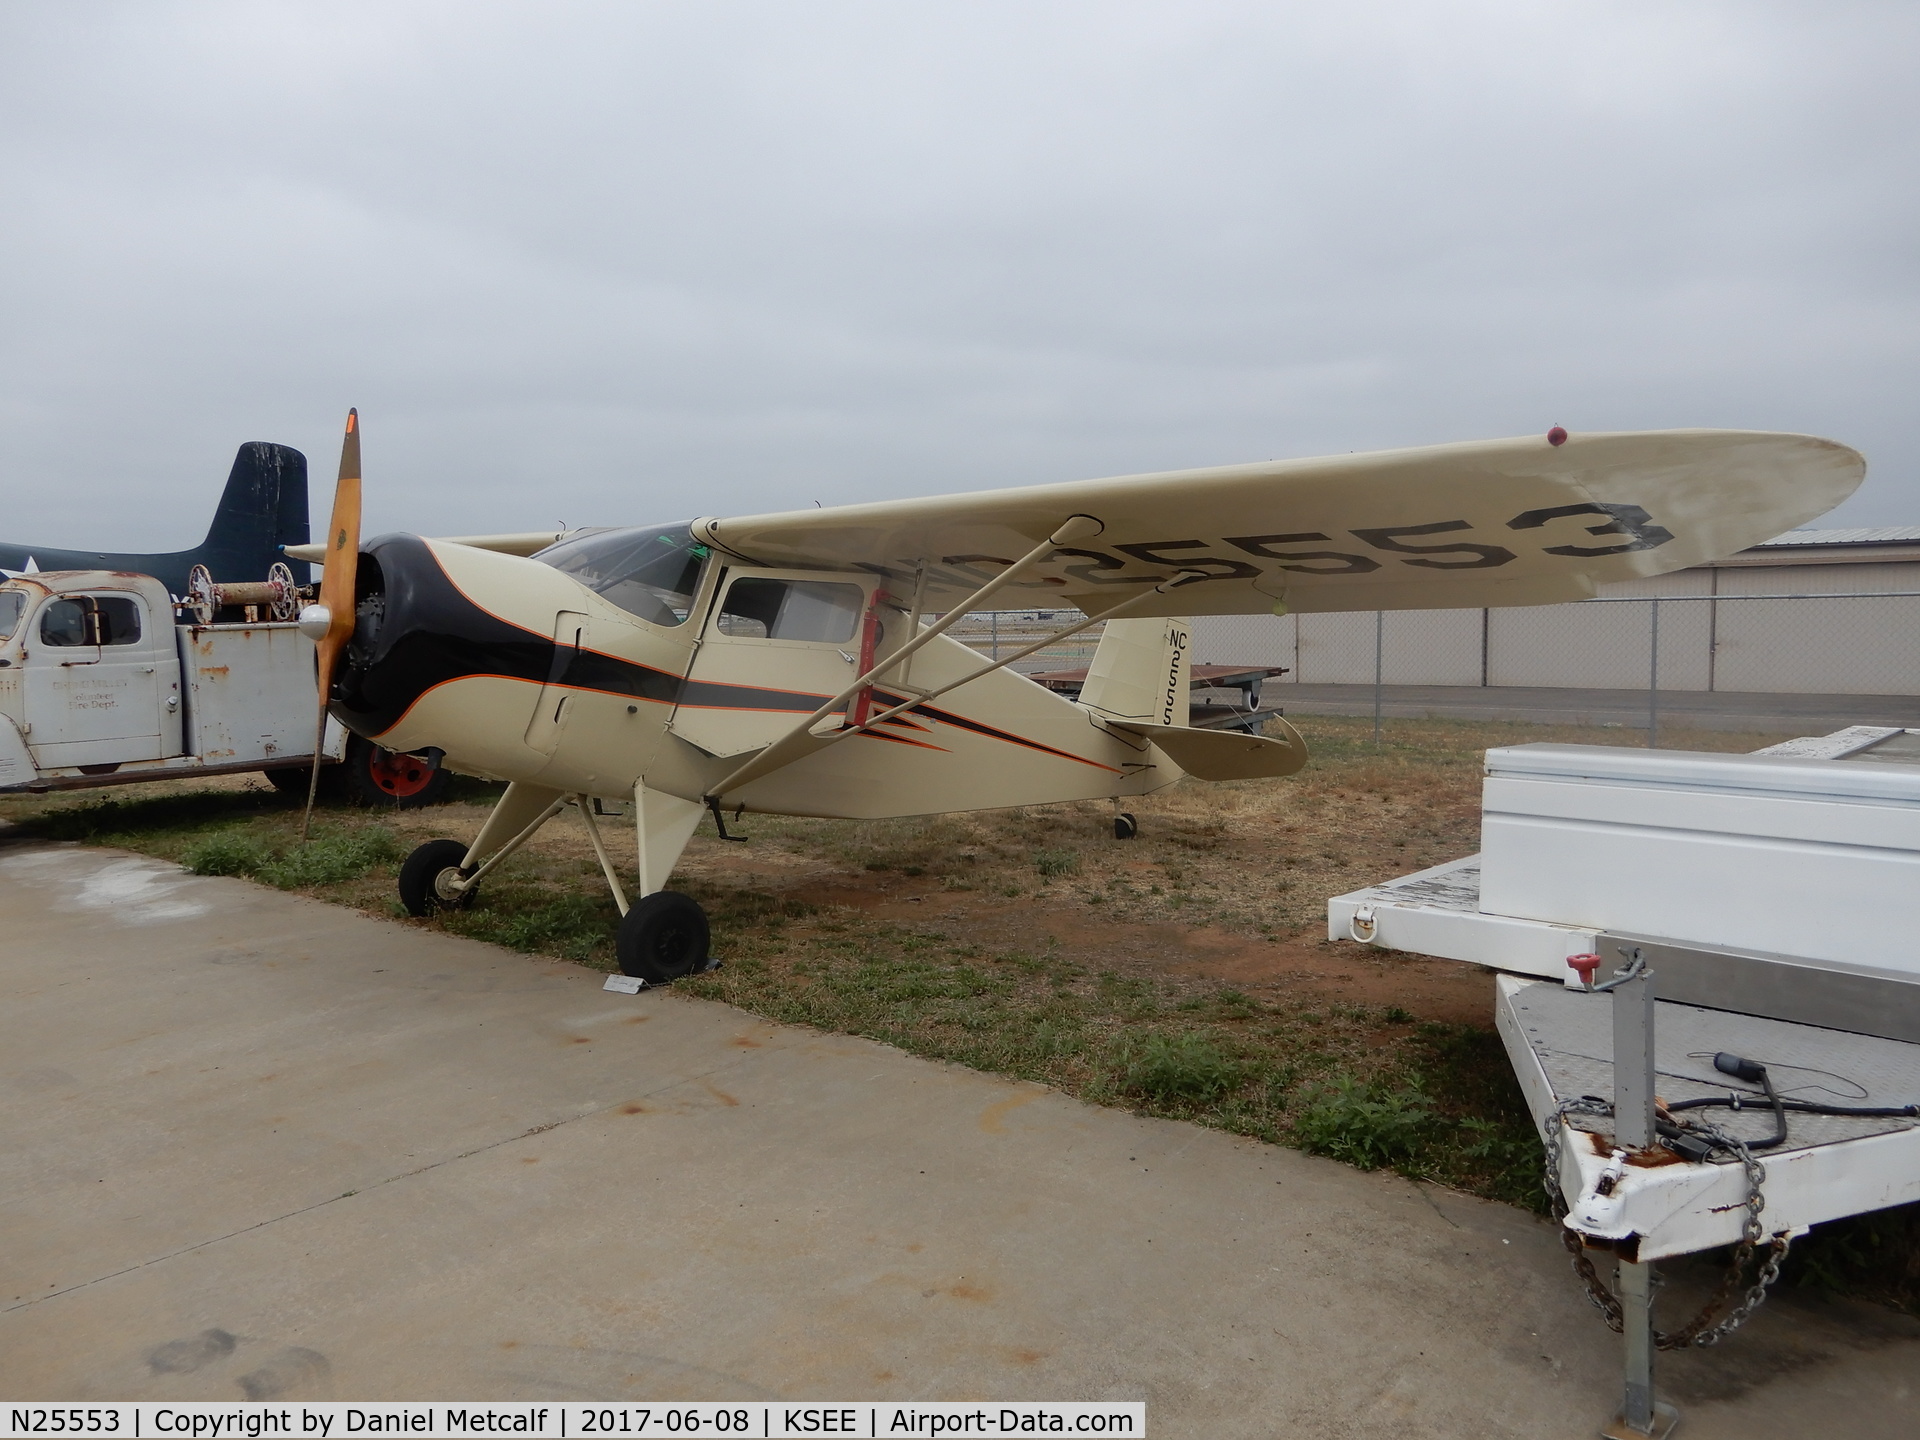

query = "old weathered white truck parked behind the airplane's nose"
[0,570,445,804]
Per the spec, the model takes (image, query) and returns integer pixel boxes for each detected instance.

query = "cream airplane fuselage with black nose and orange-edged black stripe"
[332,526,1185,818]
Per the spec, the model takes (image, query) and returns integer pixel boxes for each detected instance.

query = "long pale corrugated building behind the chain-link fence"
[1194,526,1920,695]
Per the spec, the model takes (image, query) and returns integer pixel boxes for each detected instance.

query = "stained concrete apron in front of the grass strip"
[0,845,1920,1440]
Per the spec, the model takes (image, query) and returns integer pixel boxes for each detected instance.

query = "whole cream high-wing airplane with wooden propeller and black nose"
[288,415,1866,983]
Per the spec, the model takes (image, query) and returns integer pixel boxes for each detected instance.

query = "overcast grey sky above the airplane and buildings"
[0,0,1920,549]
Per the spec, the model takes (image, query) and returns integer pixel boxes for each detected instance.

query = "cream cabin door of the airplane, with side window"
[670,570,883,756]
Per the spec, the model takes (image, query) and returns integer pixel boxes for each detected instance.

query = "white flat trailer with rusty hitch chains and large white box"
[1327,726,1920,1436]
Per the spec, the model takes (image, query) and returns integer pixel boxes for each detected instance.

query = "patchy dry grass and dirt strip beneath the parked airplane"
[0,718,1920,1308]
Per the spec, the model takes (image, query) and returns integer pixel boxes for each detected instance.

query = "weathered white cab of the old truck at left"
[0,570,182,785]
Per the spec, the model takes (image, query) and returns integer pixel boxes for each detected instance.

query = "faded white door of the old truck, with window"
[21,593,179,770]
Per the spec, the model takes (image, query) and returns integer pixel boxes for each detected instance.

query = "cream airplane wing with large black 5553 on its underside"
[693,430,1866,614]
